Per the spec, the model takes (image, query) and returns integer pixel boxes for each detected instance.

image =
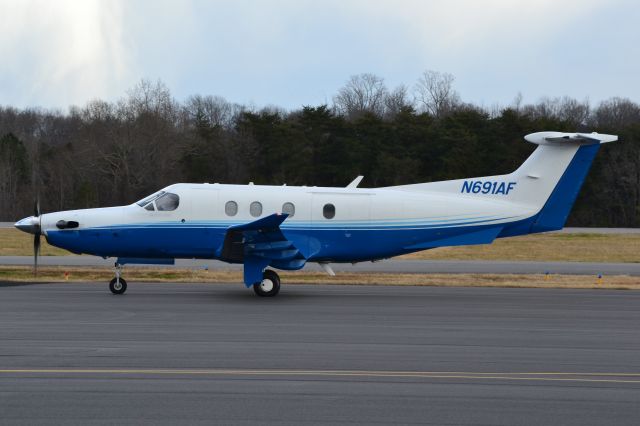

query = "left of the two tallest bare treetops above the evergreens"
[333,74,387,119]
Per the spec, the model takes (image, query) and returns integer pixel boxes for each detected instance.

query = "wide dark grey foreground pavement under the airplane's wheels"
[0,283,640,425]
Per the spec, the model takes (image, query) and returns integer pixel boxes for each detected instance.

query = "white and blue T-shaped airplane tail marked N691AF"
[382,132,618,236]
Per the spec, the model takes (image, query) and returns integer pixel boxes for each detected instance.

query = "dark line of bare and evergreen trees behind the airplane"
[0,71,640,227]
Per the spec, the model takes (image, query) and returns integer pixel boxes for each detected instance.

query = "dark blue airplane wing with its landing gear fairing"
[218,213,306,287]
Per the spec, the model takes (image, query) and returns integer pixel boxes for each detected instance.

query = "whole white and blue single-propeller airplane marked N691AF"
[15,132,618,296]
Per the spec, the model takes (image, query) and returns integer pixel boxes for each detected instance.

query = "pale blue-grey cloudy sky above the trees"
[0,0,640,110]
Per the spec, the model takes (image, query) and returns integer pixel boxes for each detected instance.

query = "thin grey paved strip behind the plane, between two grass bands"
[0,256,640,275]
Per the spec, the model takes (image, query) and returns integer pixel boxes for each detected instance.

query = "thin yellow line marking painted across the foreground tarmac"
[0,368,640,383]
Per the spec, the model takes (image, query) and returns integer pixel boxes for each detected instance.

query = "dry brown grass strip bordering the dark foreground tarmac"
[0,266,640,290]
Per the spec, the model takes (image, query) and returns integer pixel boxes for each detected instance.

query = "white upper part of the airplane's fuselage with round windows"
[36,184,535,234]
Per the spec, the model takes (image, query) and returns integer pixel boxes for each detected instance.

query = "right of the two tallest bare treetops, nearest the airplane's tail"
[414,70,460,118]
